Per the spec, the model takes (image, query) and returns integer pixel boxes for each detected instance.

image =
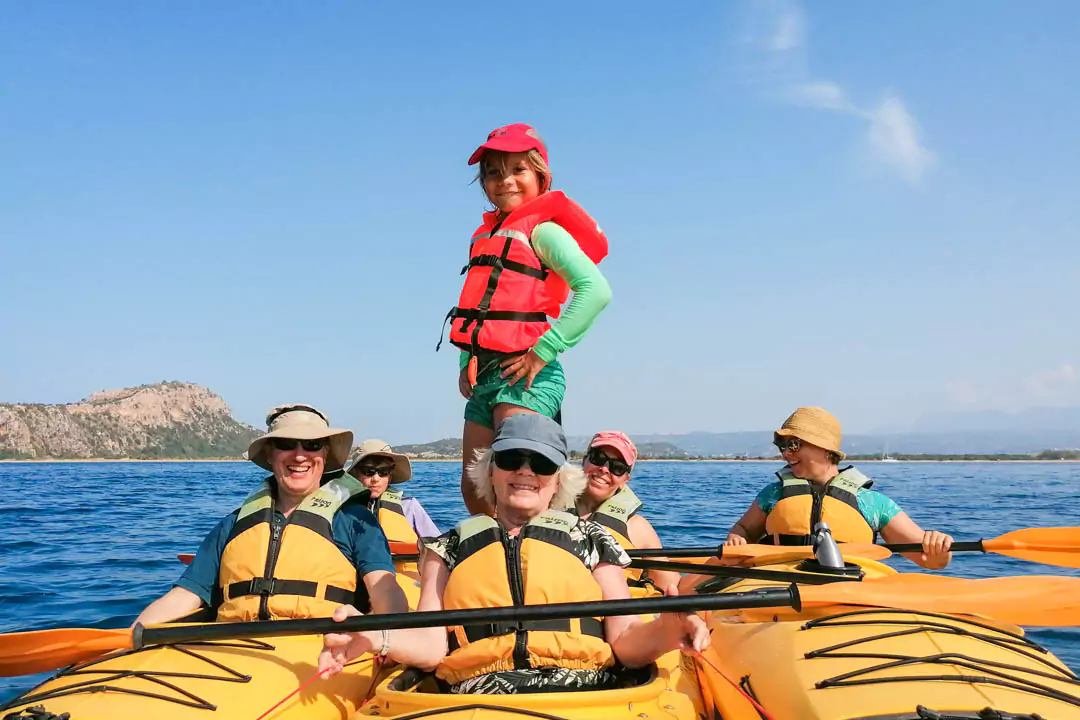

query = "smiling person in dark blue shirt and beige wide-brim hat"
[137,404,408,624]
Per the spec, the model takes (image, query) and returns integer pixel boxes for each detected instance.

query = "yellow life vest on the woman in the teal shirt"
[765,466,876,545]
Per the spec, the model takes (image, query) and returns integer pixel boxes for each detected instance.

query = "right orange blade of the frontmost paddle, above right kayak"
[799,573,1080,627]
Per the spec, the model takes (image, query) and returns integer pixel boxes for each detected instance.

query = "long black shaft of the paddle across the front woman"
[132,585,802,650]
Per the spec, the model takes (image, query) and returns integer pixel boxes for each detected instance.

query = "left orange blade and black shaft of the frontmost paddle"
[0,585,800,677]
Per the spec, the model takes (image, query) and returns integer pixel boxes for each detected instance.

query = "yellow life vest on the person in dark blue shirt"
[217,475,367,622]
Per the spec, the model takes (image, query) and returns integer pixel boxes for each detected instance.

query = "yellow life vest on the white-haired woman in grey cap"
[436,511,615,684]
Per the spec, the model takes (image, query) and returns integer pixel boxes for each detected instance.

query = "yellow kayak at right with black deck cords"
[697,548,1080,720]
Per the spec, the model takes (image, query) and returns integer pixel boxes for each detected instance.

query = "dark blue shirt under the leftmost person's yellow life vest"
[174,498,394,606]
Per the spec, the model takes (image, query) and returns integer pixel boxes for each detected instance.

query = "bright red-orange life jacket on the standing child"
[446,191,608,355]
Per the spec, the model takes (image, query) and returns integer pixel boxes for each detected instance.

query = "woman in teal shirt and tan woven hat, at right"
[725,407,953,569]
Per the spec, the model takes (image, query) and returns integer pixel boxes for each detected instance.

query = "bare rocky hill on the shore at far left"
[0,382,259,459]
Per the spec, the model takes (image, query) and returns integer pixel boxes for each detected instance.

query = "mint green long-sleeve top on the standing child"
[453,222,611,367]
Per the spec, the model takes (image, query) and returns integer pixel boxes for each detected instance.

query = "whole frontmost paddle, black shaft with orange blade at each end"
[14,573,1080,677]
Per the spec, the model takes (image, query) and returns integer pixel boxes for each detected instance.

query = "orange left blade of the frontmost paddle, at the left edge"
[0,628,132,678]
